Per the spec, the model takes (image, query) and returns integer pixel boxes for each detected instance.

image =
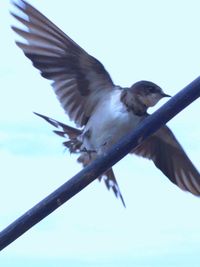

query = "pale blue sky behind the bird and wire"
[0,0,200,267]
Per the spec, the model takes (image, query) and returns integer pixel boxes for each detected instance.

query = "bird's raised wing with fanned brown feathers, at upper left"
[12,0,114,126]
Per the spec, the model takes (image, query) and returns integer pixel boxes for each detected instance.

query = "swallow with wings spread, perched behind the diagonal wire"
[11,0,200,206]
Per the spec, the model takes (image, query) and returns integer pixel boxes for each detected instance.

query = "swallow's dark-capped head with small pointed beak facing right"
[130,81,171,108]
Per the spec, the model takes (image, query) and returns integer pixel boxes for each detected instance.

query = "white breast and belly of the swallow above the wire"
[83,89,141,153]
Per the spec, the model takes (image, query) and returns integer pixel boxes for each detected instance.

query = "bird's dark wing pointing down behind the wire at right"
[132,126,200,196]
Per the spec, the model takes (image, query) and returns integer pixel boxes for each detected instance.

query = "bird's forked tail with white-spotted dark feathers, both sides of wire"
[34,112,126,207]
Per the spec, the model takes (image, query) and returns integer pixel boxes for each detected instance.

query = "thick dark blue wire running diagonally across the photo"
[0,77,200,250]
